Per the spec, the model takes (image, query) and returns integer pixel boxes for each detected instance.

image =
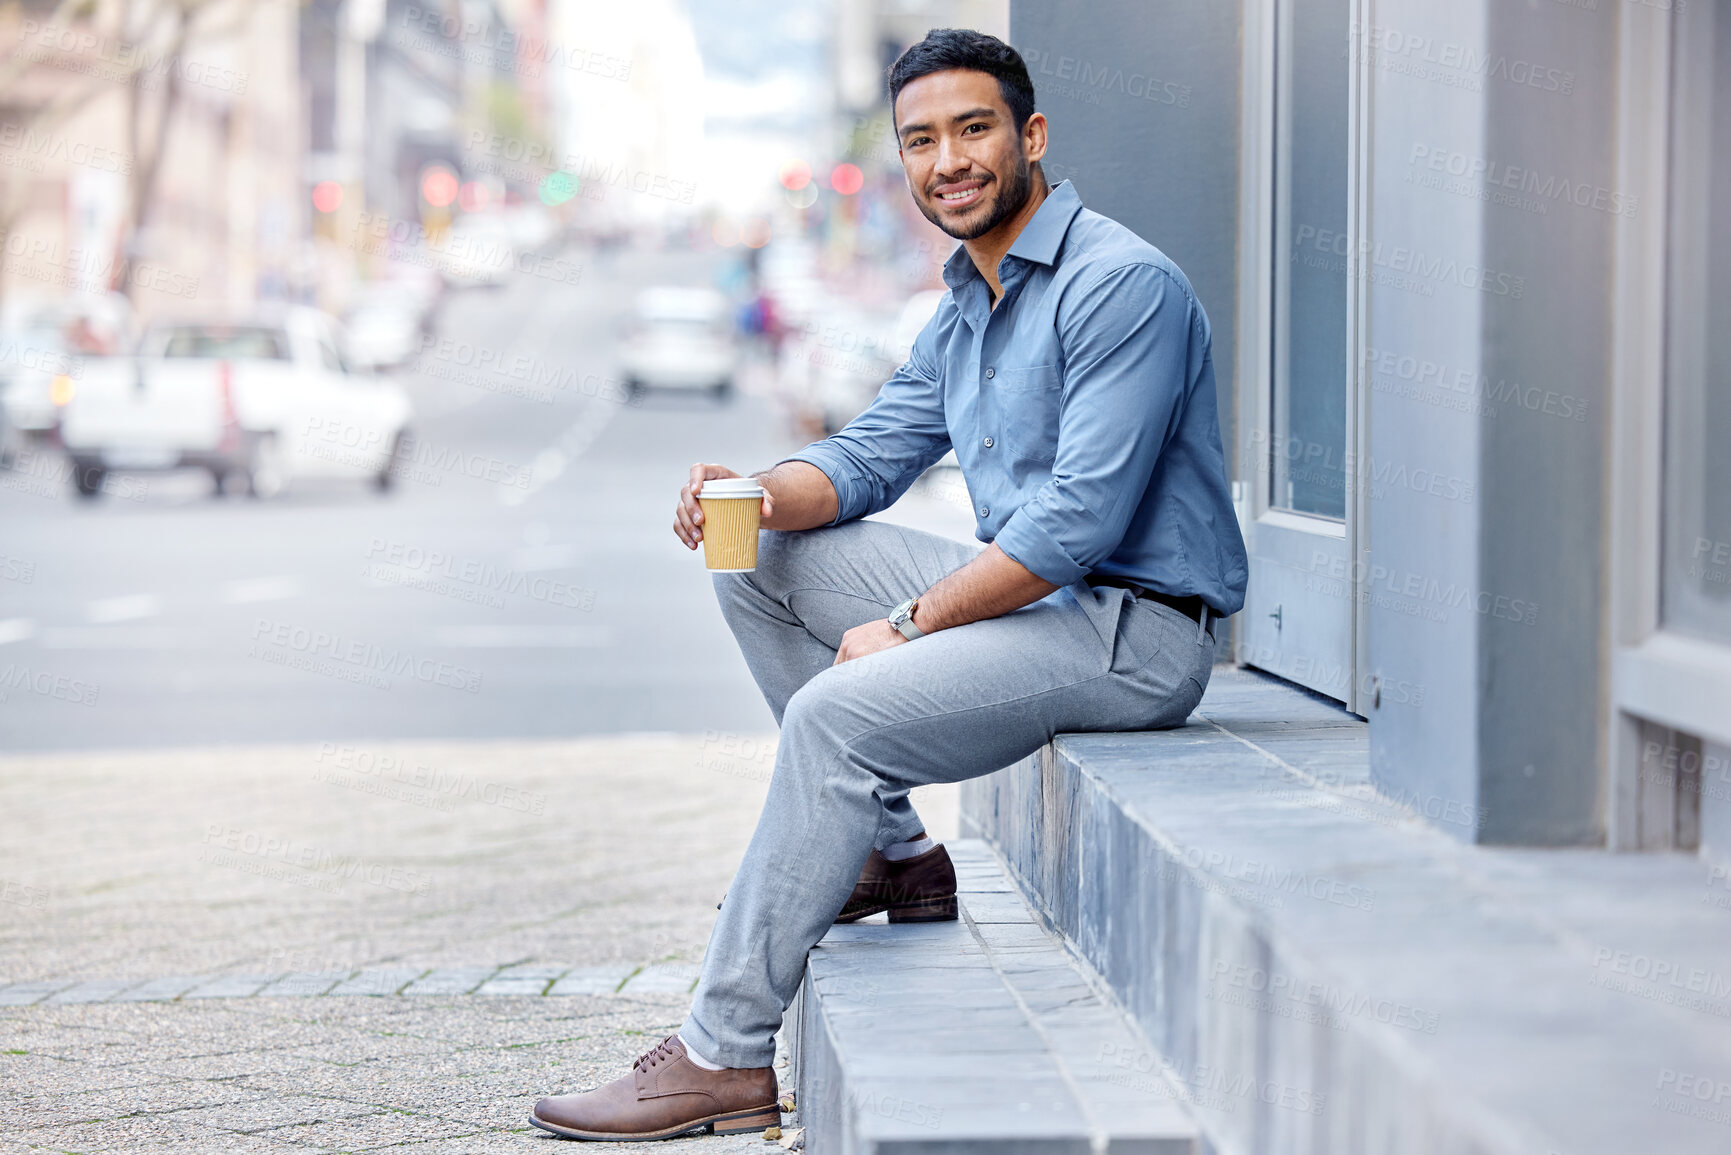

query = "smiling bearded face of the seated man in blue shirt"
[895,69,1046,241]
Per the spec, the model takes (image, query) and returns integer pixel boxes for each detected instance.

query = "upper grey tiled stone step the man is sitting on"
[962,670,1731,1155]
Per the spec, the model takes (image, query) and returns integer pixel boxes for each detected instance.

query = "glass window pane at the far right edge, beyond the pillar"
[1660,3,1731,642]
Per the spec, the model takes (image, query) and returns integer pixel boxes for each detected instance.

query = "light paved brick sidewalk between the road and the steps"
[0,732,954,1153]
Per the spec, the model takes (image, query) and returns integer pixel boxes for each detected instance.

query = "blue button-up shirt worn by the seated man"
[789,180,1248,615]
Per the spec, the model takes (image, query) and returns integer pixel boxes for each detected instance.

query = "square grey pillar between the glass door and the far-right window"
[1362,0,1639,845]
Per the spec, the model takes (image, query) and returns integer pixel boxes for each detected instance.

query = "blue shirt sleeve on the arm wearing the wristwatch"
[995,263,1194,585]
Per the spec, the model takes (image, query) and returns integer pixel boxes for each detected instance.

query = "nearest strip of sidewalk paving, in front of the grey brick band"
[0,996,772,1155]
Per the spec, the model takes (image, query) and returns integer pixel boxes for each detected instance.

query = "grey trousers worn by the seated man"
[680,521,1215,1067]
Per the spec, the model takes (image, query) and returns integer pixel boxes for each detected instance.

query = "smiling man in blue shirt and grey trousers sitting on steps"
[533,29,1246,1139]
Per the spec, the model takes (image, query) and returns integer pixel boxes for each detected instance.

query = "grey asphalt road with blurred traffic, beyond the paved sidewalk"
[0,242,969,752]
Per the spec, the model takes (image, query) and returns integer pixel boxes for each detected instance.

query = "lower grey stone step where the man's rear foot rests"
[786,840,1200,1155]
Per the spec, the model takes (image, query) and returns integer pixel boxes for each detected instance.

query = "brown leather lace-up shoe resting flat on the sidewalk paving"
[530,1034,781,1139]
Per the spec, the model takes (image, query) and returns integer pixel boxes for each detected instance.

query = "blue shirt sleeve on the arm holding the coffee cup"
[782,308,950,525]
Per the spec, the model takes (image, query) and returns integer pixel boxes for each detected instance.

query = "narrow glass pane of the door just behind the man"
[1269,0,1352,518]
